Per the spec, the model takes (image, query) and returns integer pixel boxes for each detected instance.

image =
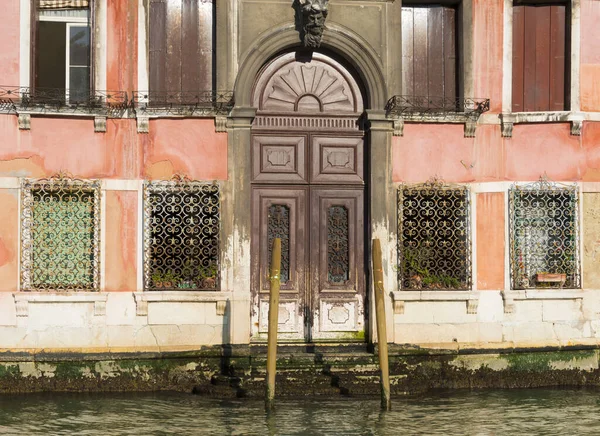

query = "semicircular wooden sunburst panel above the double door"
[252,52,364,116]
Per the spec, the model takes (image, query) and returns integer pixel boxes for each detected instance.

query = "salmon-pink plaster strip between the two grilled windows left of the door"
[104,191,141,292]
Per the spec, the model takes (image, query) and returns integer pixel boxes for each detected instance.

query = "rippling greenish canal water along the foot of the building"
[0,389,600,436]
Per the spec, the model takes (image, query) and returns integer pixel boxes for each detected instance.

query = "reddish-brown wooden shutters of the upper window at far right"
[512,5,567,112]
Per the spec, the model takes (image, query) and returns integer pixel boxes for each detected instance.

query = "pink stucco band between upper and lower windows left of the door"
[0,115,227,180]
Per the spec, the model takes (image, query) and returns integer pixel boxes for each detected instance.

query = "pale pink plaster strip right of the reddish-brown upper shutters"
[580,0,600,111]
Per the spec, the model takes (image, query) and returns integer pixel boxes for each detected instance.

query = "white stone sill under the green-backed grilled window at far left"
[13,292,108,317]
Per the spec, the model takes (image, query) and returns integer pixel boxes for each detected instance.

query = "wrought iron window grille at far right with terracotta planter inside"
[509,177,581,289]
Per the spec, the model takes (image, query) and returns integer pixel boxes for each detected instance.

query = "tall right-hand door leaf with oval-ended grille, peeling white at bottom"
[310,187,365,340]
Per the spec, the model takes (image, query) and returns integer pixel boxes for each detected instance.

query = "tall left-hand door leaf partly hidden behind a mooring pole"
[251,187,307,341]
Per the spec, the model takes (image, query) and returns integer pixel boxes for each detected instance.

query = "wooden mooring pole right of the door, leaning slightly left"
[373,239,392,410]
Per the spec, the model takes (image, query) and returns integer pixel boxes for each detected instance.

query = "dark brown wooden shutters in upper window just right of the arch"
[402,6,457,99]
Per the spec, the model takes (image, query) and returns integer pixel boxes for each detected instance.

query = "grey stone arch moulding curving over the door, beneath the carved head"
[234,23,388,109]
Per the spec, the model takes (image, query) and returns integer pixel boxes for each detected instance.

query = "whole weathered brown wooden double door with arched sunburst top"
[251,52,367,342]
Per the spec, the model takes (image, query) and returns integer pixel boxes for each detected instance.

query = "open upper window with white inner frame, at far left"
[32,0,92,103]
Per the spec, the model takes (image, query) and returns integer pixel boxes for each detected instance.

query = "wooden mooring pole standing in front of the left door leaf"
[265,238,281,410]
